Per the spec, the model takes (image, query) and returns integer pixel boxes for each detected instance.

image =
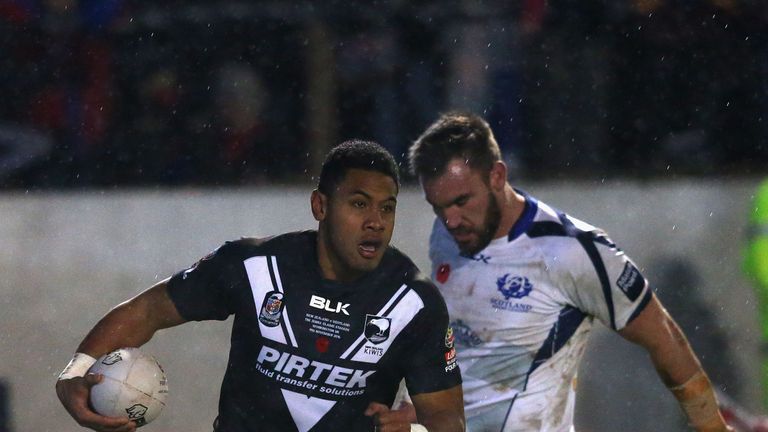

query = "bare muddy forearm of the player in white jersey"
[619,295,731,432]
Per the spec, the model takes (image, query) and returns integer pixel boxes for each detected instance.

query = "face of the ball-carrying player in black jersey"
[312,169,397,280]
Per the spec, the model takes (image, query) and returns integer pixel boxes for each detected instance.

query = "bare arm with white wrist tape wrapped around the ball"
[56,280,186,432]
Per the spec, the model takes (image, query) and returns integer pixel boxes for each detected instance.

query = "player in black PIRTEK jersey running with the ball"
[56,141,464,432]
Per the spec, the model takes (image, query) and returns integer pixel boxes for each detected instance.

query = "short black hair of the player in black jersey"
[317,140,400,195]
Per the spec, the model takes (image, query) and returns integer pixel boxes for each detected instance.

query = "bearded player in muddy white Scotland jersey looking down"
[402,113,730,432]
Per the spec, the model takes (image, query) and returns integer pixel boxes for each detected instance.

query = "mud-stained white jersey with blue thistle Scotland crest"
[430,191,652,432]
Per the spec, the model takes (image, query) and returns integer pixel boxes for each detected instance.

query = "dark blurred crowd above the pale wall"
[0,0,768,189]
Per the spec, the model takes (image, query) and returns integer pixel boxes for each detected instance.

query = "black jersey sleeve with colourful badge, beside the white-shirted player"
[402,287,461,395]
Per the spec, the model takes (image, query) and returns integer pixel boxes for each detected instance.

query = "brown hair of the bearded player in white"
[408,112,501,178]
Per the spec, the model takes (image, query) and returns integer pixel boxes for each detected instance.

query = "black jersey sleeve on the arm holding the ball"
[168,243,238,321]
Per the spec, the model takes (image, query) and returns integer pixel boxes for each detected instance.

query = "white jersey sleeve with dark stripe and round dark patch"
[562,231,652,330]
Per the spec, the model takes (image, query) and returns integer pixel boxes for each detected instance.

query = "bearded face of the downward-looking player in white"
[421,159,501,256]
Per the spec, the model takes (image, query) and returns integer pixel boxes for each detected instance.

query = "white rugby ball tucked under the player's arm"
[88,348,168,427]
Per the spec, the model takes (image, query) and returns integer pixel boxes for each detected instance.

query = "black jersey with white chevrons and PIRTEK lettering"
[168,231,461,432]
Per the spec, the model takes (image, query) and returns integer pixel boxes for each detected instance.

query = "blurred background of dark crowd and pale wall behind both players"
[0,0,768,432]
